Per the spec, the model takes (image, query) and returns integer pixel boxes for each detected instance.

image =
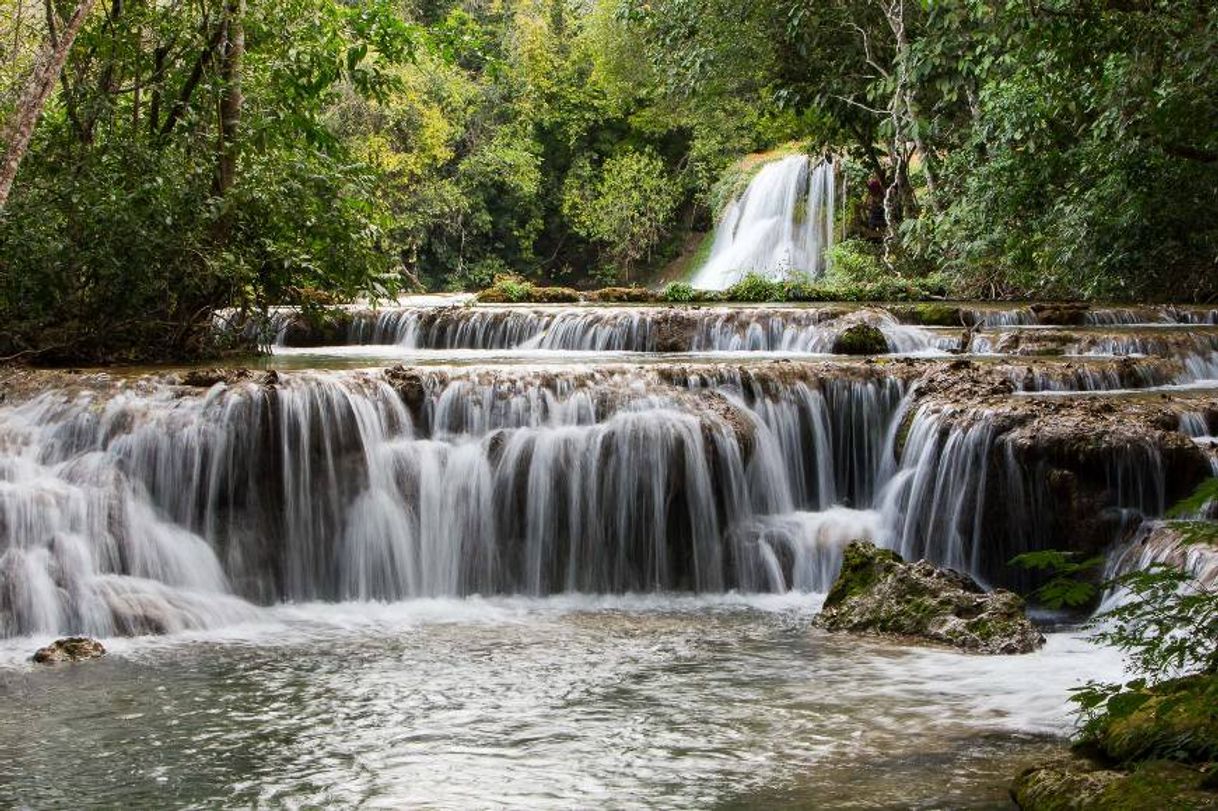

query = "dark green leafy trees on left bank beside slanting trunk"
[0,0,410,360]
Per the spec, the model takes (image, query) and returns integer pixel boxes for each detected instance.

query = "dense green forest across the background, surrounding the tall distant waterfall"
[0,0,1218,359]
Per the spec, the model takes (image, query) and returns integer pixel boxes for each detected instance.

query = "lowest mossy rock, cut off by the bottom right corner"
[1011,757,1218,811]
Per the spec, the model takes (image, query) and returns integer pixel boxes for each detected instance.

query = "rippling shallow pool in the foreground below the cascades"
[0,594,1121,809]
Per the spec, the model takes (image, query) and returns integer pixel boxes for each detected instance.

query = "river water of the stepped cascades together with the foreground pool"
[0,301,1218,807]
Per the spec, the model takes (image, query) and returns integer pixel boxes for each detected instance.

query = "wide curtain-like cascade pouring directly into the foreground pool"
[0,363,1188,634]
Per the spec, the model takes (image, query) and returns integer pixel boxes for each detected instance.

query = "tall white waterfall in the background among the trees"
[693,155,837,290]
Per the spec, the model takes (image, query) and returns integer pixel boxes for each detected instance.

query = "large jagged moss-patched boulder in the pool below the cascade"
[816,541,1045,654]
